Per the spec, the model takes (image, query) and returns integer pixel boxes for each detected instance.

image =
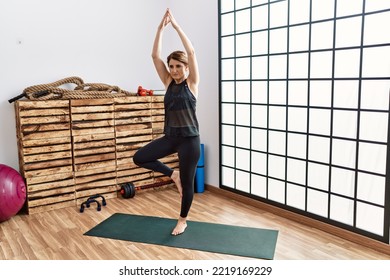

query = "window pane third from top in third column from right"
[310,52,333,78]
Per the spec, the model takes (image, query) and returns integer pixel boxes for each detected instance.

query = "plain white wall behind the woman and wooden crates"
[0,0,219,186]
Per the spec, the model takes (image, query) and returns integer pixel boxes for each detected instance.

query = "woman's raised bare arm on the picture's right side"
[167,9,199,95]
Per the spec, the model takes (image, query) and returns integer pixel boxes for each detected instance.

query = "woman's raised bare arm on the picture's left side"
[152,10,172,88]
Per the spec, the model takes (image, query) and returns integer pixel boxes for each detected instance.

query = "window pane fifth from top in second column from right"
[333,110,357,139]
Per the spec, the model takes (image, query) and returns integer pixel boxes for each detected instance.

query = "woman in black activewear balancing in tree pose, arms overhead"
[133,9,200,235]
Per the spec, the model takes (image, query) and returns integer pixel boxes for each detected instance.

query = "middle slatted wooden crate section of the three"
[70,98,117,205]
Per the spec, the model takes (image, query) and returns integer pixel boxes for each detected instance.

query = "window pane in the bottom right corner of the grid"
[356,202,385,236]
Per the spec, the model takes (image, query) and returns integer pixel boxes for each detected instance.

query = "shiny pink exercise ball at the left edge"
[0,164,26,222]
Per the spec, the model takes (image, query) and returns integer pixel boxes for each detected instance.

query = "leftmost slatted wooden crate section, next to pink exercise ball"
[15,100,75,213]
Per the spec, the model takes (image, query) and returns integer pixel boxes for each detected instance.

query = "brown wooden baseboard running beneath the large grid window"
[205,184,390,255]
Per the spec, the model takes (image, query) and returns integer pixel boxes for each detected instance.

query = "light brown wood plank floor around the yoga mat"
[0,187,390,260]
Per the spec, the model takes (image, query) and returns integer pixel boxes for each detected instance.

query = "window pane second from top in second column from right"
[336,16,362,48]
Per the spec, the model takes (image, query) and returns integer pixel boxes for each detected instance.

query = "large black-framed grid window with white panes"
[219,0,390,243]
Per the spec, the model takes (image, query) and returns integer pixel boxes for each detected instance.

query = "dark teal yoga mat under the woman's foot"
[84,213,278,259]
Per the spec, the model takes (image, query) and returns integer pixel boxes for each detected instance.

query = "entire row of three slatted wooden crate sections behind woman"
[15,96,178,213]
